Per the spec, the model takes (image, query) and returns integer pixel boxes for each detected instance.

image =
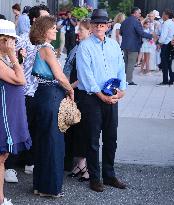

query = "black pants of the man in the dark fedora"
[79,91,118,181]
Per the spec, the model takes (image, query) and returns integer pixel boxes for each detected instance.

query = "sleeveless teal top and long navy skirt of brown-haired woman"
[33,44,65,195]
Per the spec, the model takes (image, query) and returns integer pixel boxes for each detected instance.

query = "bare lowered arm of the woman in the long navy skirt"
[40,47,74,100]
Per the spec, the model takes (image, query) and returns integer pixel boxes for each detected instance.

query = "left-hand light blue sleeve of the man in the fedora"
[76,43,101,93]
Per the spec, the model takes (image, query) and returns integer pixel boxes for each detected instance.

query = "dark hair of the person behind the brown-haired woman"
[28,4,50,25]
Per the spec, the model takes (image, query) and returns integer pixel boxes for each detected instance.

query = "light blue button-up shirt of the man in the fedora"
[76,35,127,93]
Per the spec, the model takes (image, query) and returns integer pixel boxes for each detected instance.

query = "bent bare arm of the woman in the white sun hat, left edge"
[0,39,26,85]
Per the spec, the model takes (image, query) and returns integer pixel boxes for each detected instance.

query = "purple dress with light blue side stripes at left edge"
[0,59,32,154]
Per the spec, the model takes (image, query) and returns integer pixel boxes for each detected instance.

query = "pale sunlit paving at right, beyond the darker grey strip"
[119,69,174,119]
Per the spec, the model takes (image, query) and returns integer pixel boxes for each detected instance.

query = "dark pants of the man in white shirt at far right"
[161,44,174,83]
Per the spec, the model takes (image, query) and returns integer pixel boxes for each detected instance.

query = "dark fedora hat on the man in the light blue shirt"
[91,9,109,23]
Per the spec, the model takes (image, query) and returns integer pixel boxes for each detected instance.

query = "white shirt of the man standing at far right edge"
[159,19,174,45]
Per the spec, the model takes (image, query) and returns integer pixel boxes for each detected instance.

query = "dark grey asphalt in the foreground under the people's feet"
[5,164,174,205]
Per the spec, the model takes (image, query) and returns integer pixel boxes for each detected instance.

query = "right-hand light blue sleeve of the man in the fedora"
[117,45,127,90]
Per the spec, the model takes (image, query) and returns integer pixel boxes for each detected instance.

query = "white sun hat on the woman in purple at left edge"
[0,19,19,38]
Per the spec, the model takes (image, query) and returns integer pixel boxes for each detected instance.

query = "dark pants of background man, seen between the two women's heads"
[65,31,76,55]
